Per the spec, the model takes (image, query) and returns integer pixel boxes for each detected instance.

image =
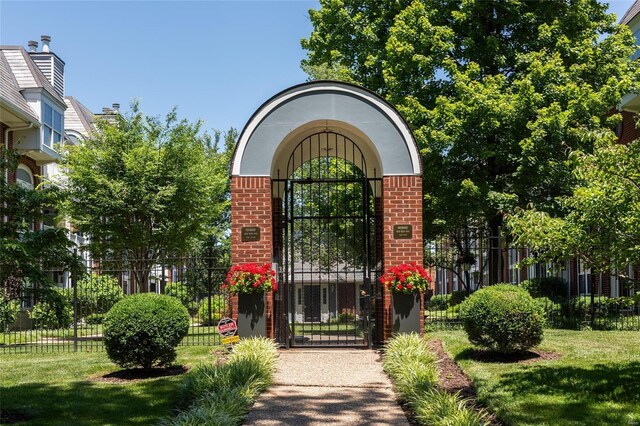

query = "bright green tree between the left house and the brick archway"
[62,103,229,291]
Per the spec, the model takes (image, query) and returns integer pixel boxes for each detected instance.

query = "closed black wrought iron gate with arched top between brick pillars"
[274,132,379,346]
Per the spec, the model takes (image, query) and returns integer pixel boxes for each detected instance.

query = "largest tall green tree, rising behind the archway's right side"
[302,0,638,281]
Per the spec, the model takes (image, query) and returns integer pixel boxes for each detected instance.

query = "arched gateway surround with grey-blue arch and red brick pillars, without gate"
[231,81,424,345]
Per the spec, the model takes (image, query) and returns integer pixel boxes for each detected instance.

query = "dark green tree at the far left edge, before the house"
[0,148,82,314]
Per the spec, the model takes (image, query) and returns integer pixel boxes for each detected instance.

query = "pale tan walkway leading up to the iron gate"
[245,349,409,426]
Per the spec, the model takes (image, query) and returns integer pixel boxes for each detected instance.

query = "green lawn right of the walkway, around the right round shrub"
[429,330,640,426]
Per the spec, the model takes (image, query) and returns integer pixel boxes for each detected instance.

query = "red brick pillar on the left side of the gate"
[231,176,274,338]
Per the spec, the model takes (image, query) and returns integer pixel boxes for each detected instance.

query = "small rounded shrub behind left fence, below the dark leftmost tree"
[29,288,73,330]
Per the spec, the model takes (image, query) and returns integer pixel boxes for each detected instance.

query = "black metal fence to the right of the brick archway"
[425,229,640,330]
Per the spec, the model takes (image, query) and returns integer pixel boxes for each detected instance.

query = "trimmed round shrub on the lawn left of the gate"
[104,293,191,368]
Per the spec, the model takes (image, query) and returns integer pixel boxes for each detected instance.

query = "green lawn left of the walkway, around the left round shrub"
[0,346,214,425]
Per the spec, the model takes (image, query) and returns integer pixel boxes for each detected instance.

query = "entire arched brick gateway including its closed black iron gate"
[231,81,423,346]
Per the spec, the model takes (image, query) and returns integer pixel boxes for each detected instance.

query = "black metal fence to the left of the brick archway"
[0,252,230,353]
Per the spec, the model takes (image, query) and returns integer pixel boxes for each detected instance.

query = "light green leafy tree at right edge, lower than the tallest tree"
[507,136,640,278]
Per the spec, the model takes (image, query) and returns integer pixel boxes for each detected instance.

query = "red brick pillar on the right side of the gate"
[378,176,424,341]
